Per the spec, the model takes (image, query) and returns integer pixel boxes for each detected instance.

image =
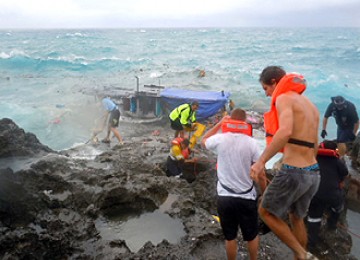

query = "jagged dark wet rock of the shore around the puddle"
[0,119,356,259]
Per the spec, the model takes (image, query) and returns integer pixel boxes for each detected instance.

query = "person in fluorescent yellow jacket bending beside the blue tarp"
[169,101,206,149]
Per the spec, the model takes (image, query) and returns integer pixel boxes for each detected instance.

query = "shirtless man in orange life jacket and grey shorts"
[251,66,320,259]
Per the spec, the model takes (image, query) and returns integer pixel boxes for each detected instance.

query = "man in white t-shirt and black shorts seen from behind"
[202,108,266,260]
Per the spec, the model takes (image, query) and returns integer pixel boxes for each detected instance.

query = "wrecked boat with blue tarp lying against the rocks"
[107,82,230,123]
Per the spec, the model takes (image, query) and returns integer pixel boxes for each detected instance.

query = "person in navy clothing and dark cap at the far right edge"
[321,96,359,157]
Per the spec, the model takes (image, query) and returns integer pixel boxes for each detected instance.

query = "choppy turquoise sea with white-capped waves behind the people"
[0,28,360,150]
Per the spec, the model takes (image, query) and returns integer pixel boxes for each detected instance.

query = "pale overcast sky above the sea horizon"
[0,0,360,29]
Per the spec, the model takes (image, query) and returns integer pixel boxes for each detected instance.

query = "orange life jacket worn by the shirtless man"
[264,73,306,148]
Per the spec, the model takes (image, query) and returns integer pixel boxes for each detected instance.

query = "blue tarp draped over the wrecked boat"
[160,88,230,121]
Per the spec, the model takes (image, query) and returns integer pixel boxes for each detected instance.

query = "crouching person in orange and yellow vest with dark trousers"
[166,137,190,178]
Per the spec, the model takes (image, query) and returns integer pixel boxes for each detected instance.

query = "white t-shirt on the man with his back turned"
[205,132,260,200]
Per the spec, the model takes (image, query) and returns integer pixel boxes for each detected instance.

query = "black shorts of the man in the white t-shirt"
[217,196,259,241]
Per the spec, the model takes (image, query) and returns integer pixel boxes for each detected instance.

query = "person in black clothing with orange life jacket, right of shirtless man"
[307,140,349,251]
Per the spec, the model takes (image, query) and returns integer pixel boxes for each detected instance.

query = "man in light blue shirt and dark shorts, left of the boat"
[102,97,123,144]
